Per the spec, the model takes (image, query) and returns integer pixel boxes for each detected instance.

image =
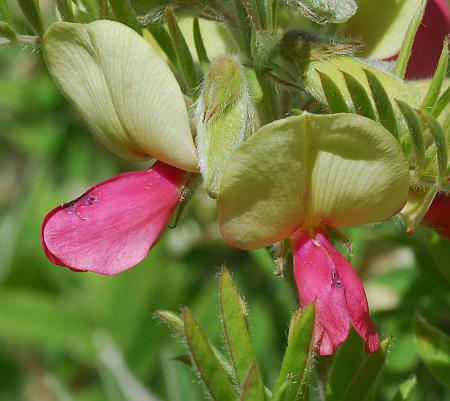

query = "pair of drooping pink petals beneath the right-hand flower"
[291,231,380,355]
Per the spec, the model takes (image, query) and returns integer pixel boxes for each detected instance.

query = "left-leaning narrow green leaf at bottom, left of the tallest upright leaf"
[183,308,236,401]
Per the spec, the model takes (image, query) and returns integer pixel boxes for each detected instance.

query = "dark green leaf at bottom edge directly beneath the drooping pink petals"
[326,330,364,401]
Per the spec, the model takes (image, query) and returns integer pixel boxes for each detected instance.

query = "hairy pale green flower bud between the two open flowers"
[195,56,254,198]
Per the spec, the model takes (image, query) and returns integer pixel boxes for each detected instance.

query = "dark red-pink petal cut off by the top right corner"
[406,0,450,79]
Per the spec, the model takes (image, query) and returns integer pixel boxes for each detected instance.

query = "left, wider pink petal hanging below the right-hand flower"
[292,233,350,355]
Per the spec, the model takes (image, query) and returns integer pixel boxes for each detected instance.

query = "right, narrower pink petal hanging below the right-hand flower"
[317,233,380,352]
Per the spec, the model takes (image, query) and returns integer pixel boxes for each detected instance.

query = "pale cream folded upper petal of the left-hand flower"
[43,20,197,171]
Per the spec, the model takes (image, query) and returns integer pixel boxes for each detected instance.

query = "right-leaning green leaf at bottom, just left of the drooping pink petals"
[273,303,315,401]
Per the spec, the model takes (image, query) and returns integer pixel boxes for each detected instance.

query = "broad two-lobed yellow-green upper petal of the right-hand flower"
[218,114,410,249]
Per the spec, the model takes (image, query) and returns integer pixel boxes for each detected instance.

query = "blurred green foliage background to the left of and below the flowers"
[0,1,450,401]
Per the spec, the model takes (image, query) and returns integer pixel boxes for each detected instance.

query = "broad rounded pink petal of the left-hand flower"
[41,162,189,274]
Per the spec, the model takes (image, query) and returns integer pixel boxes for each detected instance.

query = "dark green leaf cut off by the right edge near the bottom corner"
[413,316,450,388]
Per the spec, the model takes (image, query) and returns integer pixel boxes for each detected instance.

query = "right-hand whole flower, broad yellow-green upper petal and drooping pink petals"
[217,113,409,355]
